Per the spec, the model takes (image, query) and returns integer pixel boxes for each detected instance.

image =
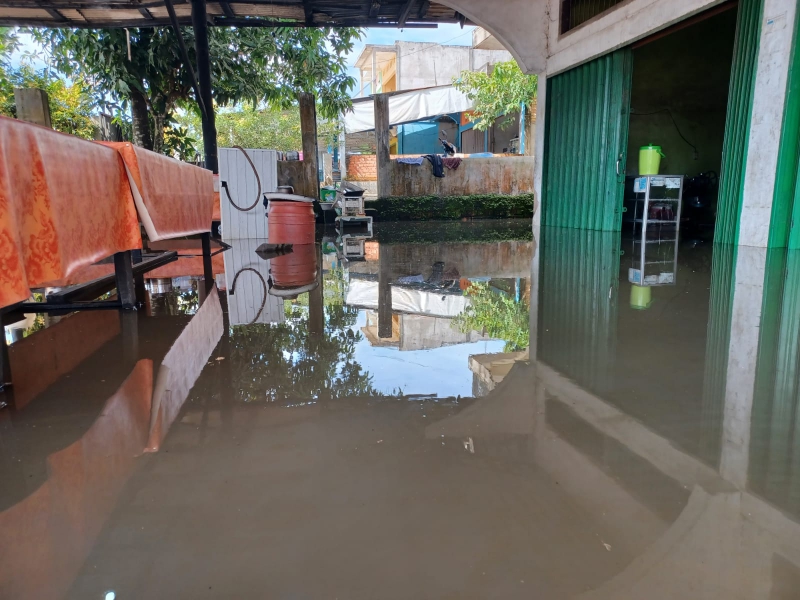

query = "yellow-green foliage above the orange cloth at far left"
[0,65,95,140]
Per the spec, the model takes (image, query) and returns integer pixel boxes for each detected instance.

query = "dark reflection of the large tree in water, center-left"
[230,303,379,403]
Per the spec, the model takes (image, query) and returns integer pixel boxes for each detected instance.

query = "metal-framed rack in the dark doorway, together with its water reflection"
[628,175,683,287]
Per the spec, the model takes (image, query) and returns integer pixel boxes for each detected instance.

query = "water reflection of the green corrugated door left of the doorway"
[538,227,620,393]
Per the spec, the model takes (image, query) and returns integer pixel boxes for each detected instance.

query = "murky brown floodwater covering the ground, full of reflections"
[0,222,800,600]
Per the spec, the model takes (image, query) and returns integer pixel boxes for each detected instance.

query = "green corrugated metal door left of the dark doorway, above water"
[542,48,633,231]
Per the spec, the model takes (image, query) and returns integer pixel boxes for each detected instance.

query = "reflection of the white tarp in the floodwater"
[345,279,469,317]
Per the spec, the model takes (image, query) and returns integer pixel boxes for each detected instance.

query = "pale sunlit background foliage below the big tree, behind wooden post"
[175,106,338,152]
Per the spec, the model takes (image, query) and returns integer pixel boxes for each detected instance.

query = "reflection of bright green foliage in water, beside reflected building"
[455,282,530,352]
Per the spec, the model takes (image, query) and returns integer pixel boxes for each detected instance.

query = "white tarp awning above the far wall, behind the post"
[344,85,474,133]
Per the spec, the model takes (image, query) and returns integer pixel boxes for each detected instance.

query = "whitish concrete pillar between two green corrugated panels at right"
[739,0,797,248]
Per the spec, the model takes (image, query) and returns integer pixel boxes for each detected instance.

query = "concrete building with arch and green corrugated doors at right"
[424,0,800,247]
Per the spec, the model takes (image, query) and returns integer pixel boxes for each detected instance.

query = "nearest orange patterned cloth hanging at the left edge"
[0,117,142,307]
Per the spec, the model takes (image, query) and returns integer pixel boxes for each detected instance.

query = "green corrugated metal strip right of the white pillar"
[769,10,800,249]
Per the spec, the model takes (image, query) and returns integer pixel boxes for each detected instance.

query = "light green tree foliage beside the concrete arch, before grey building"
[453,60,538,131]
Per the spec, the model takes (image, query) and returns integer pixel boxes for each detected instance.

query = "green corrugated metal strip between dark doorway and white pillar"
[714,0,764,244]
